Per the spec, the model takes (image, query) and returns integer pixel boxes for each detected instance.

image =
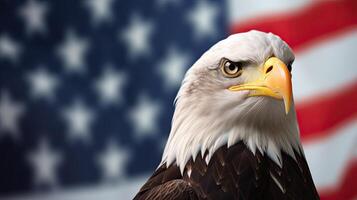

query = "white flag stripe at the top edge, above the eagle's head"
[228,0,313,24]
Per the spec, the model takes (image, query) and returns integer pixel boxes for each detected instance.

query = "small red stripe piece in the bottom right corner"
[319,160,357,200]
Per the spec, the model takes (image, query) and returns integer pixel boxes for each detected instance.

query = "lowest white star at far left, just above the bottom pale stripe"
[27,139,61,186]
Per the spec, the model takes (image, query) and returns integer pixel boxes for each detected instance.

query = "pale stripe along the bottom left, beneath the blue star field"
[0,175,149,200]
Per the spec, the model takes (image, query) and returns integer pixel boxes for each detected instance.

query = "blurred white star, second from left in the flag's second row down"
[58,31,89,72]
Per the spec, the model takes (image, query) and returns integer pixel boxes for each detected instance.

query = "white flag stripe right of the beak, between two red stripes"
[292,29,357,101]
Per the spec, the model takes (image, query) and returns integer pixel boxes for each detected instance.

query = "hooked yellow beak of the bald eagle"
[228,57,292,114]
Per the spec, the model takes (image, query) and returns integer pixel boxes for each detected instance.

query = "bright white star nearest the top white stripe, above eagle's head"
[187,0,218,39]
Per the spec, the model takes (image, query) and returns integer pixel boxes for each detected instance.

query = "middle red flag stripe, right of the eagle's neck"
[296,82,357,141]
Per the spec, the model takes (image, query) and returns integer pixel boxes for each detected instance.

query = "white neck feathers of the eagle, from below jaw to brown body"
[160,93,303,173]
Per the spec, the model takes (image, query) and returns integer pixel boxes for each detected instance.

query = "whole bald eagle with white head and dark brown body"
[134,31,319,200]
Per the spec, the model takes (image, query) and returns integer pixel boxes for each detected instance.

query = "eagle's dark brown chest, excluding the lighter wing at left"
[183,142,318,199]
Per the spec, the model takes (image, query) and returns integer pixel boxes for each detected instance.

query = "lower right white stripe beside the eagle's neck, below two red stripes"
[303,119,357,188]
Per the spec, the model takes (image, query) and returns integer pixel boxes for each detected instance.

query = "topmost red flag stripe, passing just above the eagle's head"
[231,0,357,51]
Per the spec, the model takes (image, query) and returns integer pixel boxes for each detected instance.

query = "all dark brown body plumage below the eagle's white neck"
[134,142,319,200]
